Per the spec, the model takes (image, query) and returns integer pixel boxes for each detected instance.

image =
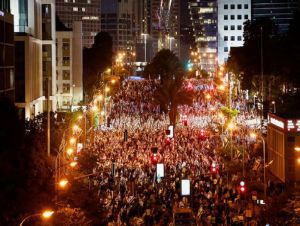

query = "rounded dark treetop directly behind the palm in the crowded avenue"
[144,49,183,83]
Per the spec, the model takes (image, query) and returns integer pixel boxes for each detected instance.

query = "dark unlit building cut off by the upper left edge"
[0,0,15,102]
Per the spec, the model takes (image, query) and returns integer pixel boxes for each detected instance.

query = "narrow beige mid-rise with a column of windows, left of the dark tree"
[56,21,83,111]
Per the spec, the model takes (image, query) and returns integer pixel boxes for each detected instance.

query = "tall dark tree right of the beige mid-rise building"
[83,32,113,100]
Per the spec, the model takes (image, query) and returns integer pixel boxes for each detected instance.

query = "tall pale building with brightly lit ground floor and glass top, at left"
[11,0,56,118]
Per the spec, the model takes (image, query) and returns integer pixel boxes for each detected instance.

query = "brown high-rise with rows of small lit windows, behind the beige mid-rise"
[56,0,101,48]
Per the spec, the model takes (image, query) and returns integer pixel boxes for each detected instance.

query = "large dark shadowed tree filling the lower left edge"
[0,99,54,225]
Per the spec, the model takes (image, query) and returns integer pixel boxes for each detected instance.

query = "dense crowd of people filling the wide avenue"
[87,80,258,225]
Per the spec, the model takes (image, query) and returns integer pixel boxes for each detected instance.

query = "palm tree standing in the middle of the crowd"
[154,78,194,125]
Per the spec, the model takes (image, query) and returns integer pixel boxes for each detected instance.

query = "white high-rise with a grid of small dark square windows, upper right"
[218,0,251,64]
